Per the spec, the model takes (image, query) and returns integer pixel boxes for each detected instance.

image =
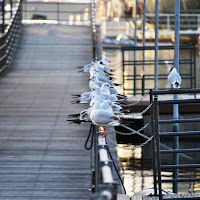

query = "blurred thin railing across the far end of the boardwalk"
[23,1,91,25]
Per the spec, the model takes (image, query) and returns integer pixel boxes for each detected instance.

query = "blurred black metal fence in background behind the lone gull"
[122,45,196,95]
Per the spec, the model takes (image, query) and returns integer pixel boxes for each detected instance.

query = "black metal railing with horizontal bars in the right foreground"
[150,89,200,200]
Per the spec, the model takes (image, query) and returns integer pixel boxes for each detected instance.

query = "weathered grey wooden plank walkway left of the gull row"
[0,25,92,200]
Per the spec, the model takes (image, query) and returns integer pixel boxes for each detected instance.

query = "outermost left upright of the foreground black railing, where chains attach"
[149,89,157,195]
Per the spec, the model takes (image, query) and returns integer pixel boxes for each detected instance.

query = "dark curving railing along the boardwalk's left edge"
[0,1,22,72]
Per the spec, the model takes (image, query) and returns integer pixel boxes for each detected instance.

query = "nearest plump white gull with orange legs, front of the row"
[90,101,120,137]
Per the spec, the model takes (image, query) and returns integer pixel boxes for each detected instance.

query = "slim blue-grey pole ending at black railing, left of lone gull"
[154,0,159,90]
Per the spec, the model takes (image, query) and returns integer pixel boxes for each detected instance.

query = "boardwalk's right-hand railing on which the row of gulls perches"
[90,0,118,200]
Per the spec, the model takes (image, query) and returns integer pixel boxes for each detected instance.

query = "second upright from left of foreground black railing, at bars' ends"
[153,97,162,200]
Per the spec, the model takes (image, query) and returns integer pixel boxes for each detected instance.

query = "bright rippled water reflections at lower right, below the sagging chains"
[118,144,200,196]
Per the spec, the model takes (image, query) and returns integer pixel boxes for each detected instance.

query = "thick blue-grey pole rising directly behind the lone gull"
[173,0,180,193]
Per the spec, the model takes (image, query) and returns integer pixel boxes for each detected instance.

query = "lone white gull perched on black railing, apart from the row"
[168,67,181,89]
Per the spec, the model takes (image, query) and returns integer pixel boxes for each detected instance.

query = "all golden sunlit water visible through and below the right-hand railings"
[103,45,200,196]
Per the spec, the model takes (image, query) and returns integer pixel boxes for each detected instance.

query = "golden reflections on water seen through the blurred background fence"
[103,44,200,95]
